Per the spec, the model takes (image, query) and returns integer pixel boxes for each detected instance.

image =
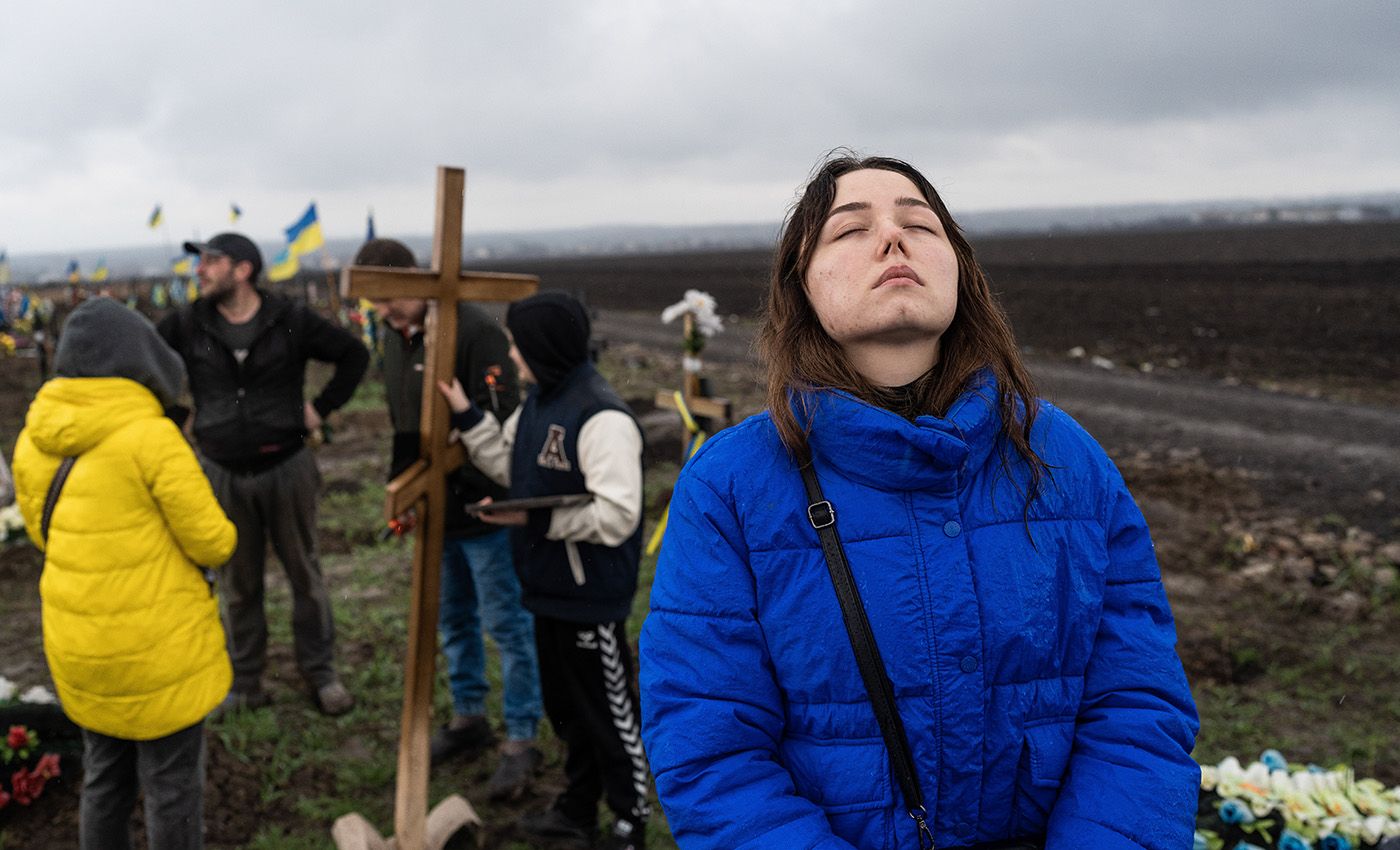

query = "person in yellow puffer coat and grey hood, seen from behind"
[14,298,237,849]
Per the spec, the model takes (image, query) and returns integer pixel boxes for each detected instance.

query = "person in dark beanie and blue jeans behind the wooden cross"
[354,239,543,801]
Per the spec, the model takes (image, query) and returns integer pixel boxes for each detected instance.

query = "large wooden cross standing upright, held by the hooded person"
[340,165,539,850]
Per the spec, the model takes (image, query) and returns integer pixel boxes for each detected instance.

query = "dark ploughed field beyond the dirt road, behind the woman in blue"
[491,221,1400,405]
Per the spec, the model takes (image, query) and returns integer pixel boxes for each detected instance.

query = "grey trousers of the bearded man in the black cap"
[203,450,336,693]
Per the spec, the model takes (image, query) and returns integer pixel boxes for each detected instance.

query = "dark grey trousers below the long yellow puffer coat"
[78,721,204,850]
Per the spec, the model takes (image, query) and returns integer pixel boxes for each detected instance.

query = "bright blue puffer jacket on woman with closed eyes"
[641,382,1198,850]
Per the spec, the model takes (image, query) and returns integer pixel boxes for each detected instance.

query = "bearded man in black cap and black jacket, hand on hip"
[158,232,370,716]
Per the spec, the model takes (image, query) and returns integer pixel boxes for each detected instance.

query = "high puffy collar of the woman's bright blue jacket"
[792,372,1001,490]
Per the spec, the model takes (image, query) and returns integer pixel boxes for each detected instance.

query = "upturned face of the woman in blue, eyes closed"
[805,168,958,377]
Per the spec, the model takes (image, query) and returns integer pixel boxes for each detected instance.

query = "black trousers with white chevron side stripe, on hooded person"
[535,615,651,825]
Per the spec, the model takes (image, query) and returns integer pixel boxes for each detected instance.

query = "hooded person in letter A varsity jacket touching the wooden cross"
[438,293,650,850]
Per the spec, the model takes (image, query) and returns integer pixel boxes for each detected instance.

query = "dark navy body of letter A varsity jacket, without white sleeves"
[511,363,643,623]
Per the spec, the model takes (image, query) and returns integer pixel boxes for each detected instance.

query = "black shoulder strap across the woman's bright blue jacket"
[801,461,934,850]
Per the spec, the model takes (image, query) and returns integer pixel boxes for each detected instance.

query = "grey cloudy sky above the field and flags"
[0,0,1400,253]
